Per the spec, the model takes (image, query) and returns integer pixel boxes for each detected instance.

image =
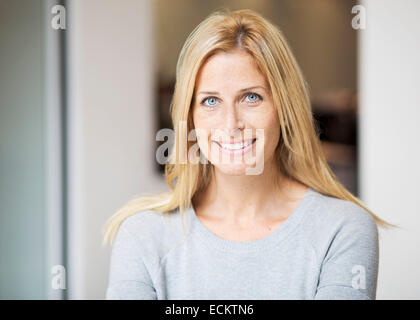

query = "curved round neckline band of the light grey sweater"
[187,187,317,253]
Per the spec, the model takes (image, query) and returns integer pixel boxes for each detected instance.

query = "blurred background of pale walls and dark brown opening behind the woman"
[0,0,420,299]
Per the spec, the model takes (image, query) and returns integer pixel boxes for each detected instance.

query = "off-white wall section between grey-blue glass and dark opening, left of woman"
[67,0,164,299]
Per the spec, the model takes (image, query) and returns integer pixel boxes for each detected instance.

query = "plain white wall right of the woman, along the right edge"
[359,0,420,299]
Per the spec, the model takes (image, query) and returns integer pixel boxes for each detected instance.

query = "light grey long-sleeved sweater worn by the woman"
[106,188,379,300]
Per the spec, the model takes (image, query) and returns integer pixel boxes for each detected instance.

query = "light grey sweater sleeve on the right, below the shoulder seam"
[315,207,379,300]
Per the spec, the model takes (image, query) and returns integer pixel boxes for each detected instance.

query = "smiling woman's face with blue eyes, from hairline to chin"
[193,50,280,175]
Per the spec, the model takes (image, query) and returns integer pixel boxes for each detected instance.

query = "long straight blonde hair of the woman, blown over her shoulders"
[103,9,394,245]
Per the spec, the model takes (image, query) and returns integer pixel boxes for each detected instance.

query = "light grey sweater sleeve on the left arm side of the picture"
[106,221,156,300]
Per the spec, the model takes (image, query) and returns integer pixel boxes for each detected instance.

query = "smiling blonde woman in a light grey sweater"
[104,10,390,299]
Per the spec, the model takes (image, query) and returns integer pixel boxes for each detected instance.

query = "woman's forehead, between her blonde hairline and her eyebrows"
[196,50,266,91]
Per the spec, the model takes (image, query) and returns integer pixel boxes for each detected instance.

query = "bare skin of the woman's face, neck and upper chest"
[192,50,306,241]
